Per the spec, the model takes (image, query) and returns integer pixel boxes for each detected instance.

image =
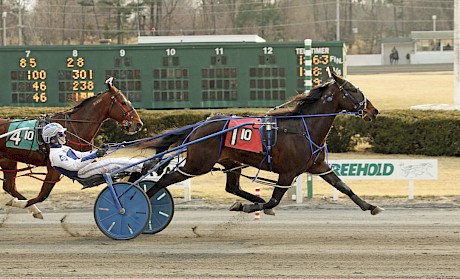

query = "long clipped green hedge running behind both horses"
[3,108,460,156]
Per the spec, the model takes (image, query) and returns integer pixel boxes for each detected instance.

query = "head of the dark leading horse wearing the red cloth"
[326,67,379,121]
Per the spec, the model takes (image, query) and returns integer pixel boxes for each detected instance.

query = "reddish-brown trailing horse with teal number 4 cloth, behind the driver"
[0,78,143,219]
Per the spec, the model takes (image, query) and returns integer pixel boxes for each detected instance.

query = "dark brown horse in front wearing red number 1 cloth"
[147,68,383,215]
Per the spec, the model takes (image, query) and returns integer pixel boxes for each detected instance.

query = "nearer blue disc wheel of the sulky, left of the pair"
[94,182,151,239]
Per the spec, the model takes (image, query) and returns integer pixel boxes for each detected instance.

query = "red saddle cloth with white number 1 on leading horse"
[225,118,262,153]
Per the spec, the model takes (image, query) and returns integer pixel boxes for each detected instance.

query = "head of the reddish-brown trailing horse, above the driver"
[105,77,144,134]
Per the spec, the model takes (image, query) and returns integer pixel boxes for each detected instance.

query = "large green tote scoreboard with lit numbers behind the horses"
[0,42,345,109]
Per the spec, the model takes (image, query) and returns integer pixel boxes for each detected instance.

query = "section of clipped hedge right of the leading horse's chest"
[328,110,460,156]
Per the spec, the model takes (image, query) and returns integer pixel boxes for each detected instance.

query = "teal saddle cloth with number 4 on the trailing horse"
[6,119,38,151]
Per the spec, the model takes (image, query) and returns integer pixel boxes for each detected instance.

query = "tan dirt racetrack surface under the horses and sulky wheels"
[0,204,460,278]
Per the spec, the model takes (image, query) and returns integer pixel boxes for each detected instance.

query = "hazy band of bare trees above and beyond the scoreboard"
[0,0,454,53]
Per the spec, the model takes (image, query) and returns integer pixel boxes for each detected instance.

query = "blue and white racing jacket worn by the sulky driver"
[49,145,96,178]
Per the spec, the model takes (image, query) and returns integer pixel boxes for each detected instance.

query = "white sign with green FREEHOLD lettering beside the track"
[329,159,438,180]
